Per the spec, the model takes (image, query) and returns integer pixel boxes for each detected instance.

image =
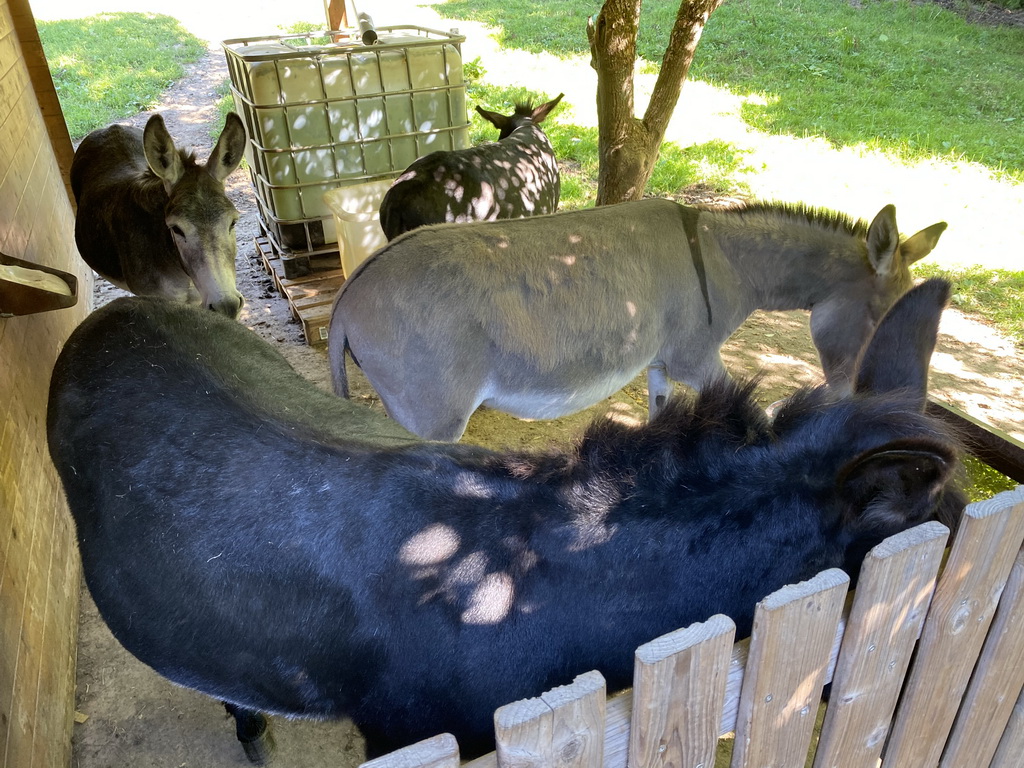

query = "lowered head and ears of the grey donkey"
[811,205,946,393]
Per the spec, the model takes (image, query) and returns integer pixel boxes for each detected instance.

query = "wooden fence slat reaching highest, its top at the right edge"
[883,486,1024,768]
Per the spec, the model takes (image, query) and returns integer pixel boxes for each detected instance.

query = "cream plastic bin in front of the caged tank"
[324,176,395,278]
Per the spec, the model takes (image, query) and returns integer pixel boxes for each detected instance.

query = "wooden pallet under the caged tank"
[254,237,345,347]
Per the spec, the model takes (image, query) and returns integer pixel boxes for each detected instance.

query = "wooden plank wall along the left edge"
[0,0,92,768]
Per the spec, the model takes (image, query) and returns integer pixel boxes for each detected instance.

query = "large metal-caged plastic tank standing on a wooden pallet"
[223,27,469,250]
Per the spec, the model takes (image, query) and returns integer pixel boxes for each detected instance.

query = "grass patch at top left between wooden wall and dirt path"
[38,13,206,139]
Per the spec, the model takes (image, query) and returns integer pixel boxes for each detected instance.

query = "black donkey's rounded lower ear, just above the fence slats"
[837,439,956,535]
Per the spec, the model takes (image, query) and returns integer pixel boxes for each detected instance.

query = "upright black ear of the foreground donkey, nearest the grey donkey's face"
[854,278,950,410]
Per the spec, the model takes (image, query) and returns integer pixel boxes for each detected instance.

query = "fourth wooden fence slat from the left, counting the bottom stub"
[732,568,850,768]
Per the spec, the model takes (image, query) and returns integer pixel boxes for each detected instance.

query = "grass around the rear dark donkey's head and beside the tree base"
[468,82,753,210]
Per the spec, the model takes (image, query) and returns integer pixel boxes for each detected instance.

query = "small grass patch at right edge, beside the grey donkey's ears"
[913,263,1024,351]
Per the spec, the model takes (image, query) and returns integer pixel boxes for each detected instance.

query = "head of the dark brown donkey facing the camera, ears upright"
[142,113,246,317]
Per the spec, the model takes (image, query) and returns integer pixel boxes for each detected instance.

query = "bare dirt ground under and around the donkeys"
[73,28,1024,768]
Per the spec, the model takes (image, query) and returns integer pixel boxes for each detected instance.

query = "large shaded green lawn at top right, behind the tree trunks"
[438,0,1024,181]
